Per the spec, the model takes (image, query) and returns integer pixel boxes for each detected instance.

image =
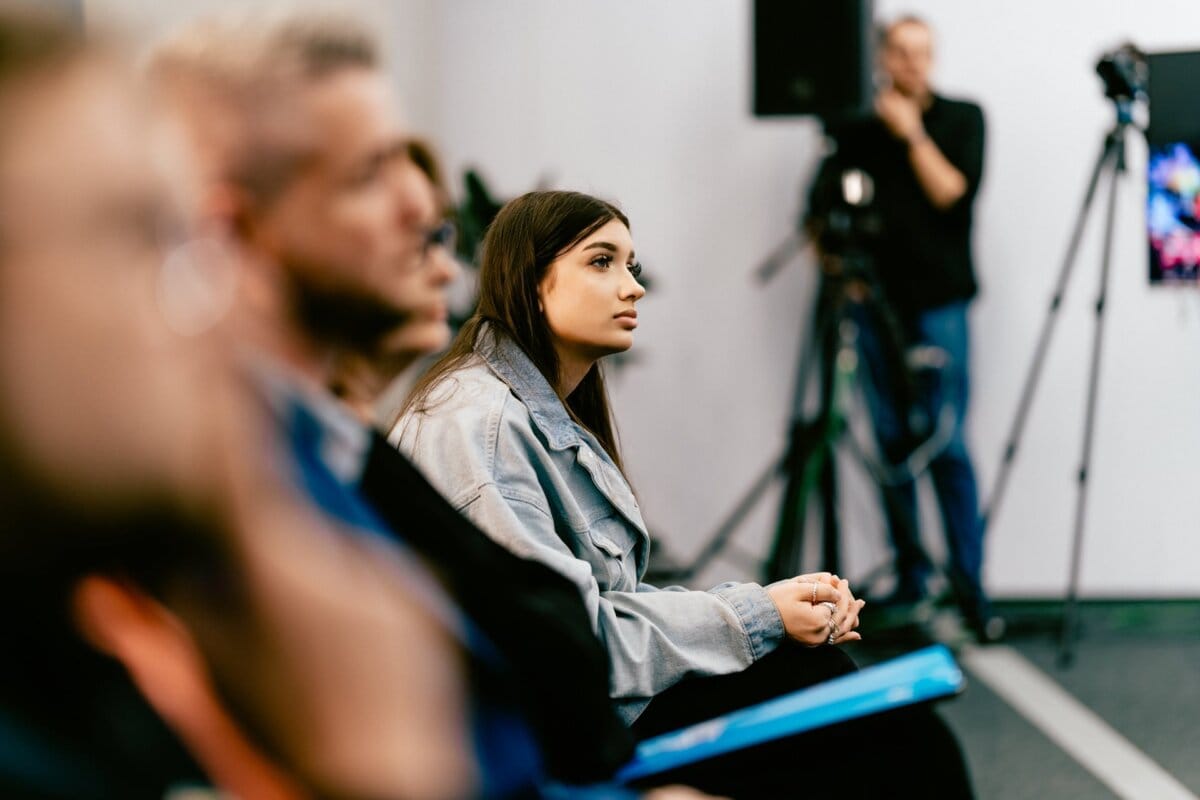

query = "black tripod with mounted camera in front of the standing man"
[654,161,953,594]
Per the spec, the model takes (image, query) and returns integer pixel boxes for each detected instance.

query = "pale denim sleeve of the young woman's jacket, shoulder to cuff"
[398,369,784,722]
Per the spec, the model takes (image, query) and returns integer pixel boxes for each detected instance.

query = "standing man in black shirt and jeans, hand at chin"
[827,17,1002,640]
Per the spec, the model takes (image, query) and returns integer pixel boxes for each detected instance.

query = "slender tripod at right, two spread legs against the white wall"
[983,97,1133,666]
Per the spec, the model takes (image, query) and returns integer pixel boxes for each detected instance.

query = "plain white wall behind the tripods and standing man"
[85,0,1200,596]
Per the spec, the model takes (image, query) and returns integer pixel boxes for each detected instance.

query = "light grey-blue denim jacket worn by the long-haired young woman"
[391,327,784,722]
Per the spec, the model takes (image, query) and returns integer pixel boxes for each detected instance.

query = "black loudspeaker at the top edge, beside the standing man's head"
[754,0,875,116]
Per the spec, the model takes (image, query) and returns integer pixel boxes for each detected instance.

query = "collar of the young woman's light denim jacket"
[475,323,583,450]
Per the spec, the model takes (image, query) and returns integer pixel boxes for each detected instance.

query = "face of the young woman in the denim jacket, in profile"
[538,219,646,360]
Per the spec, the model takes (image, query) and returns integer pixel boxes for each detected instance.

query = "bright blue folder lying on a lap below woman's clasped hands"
[617,644,964,782]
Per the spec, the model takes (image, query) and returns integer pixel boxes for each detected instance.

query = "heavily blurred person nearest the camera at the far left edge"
[0,9,478,799]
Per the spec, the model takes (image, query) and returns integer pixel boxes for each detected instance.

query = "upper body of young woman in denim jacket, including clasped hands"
[394,192,862,722]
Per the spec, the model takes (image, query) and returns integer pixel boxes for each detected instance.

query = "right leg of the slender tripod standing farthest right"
[1058,128,1124,667]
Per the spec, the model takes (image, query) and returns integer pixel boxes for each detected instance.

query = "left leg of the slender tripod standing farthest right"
[982,134,1122,533]
